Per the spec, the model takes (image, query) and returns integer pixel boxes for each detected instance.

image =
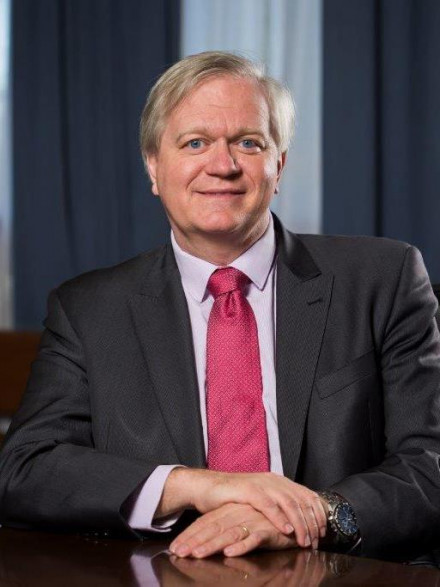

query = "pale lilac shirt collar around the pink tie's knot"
[171,214,276,302]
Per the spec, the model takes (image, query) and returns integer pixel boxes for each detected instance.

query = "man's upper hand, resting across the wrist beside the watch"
[156,468,327,548]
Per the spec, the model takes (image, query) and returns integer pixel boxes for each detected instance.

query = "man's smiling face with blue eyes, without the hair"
[147,76,284,252]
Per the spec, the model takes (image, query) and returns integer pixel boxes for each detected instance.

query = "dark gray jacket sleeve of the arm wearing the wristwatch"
[331,247,440,559]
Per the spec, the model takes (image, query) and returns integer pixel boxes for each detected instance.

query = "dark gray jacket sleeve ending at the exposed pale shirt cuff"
[0,292,154,534]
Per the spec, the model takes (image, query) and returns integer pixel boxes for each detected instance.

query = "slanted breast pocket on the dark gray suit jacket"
[316,350,377,398]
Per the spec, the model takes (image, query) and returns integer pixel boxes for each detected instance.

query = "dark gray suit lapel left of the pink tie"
[131,246,205,467]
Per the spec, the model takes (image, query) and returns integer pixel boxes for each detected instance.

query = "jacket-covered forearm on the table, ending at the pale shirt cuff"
[0,441,148,533]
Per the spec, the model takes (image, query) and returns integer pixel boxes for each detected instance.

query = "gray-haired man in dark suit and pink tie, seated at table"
[0,52,440,558]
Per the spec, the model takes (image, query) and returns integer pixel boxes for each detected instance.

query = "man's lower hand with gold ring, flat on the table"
[170,503,297,558]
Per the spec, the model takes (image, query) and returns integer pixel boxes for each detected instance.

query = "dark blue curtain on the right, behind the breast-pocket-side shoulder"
[323,0,440,282]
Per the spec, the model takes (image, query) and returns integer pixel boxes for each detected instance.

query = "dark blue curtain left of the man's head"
[12,0,180,328]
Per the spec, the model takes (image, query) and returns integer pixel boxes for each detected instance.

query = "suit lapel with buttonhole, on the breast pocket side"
[275,222,333,479]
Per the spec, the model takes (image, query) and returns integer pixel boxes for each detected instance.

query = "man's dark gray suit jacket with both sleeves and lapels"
[0,221,440,558]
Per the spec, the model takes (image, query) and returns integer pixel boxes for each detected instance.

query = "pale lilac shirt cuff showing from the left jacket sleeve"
[128,465,183,532]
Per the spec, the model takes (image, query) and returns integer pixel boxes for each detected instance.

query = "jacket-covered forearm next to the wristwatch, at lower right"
[331,450,440,560]
